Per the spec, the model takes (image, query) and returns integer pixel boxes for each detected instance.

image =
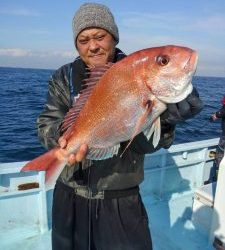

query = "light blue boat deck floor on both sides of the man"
[0,190,213,250]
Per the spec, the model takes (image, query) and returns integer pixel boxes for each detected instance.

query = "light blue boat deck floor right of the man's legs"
[144,193,213,250]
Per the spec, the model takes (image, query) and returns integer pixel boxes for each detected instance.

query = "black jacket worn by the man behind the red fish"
[37,49,174,190]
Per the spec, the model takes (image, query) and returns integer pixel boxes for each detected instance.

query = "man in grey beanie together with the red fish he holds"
[24,3,203,250]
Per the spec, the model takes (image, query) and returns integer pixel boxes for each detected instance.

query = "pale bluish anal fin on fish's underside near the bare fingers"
[86,144,120,160]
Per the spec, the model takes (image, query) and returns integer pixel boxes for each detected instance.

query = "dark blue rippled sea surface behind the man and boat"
[0,67,225,163]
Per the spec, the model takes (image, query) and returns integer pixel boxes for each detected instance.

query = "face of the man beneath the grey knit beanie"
[76,28,116,67]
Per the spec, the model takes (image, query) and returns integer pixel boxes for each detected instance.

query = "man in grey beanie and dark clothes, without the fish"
[38,3,202,250]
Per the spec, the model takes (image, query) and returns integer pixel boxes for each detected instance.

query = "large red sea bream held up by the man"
[22,45,197,189]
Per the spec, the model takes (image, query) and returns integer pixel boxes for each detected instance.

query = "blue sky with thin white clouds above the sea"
[0,0,225,76]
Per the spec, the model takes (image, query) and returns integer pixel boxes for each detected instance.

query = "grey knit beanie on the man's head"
[73,3,119,43]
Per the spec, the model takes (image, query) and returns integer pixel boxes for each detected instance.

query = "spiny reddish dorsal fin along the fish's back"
[61,63,113,133]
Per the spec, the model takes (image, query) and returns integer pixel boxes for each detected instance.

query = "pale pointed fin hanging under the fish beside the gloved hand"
[144,117,161,148]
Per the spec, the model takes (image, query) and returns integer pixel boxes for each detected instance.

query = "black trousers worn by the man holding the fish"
[52,183,152,250]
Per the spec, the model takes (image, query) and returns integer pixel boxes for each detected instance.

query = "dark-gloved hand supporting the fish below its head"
[160,88,203,125]
